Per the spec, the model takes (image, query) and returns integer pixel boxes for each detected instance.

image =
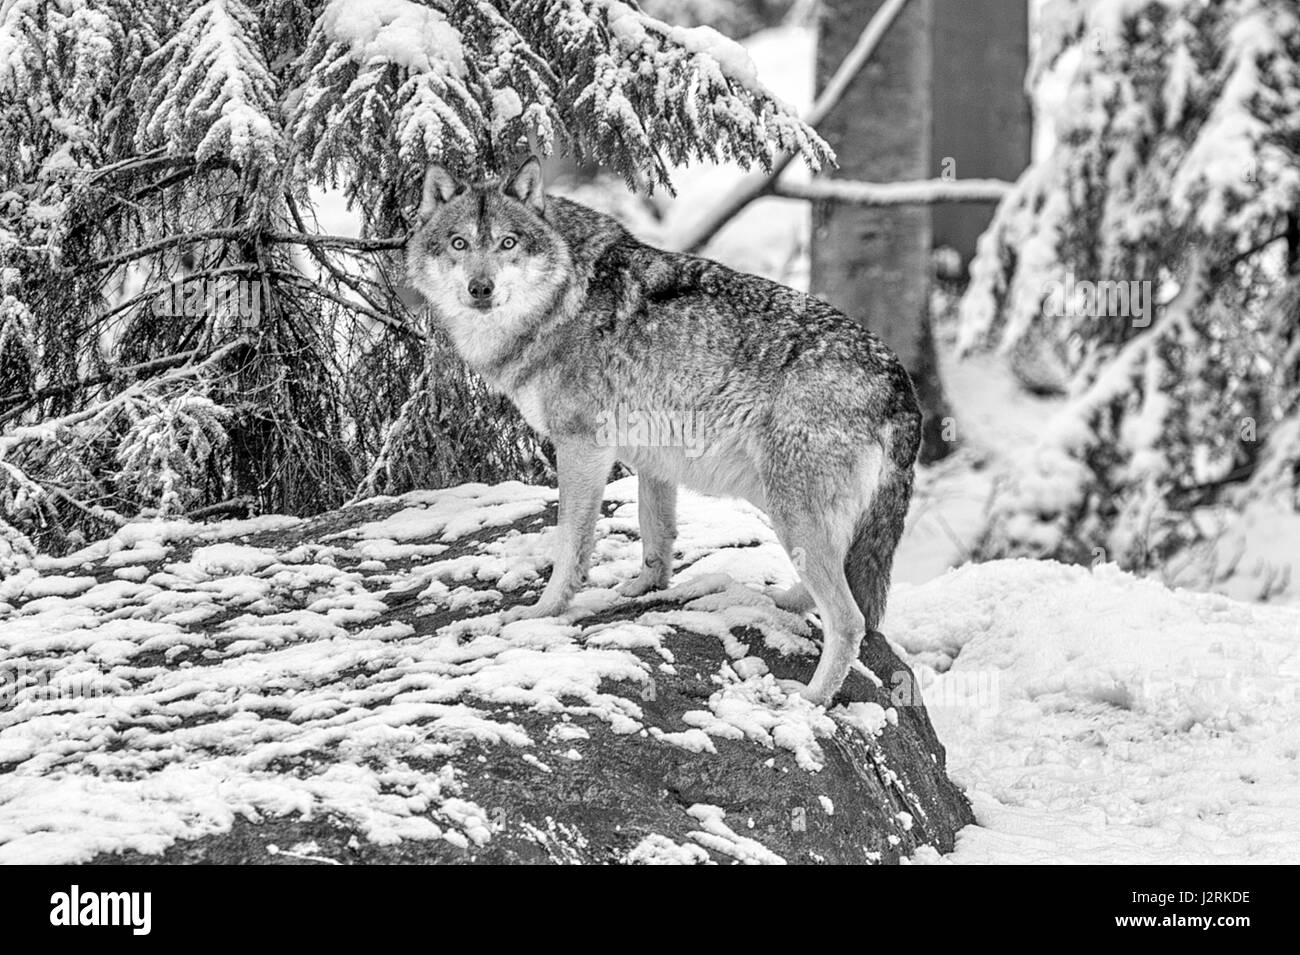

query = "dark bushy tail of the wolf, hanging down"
[844,414,920,634]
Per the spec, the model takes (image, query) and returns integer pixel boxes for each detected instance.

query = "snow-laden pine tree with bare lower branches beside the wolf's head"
[0,0,828,561]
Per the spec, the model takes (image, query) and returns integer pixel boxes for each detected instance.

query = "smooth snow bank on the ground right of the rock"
[881,560,1300,864]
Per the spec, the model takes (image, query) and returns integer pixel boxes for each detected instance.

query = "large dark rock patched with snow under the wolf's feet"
[0,482,972,864]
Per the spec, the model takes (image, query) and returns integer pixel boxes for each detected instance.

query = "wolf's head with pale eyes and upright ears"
[407,159,569,363]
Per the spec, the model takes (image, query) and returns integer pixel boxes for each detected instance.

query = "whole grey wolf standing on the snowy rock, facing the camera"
[407,159,920,704]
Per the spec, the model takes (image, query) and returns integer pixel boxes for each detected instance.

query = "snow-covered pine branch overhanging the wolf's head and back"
[290,0,828,203]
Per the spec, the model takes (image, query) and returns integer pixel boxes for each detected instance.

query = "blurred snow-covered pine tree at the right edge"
[961,0,1300,568]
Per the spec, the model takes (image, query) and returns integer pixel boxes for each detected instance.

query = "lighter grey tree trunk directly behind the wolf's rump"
[811,0,953,461]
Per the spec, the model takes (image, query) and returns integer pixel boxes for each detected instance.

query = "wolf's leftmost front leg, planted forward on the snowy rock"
[506,438,614,620]
